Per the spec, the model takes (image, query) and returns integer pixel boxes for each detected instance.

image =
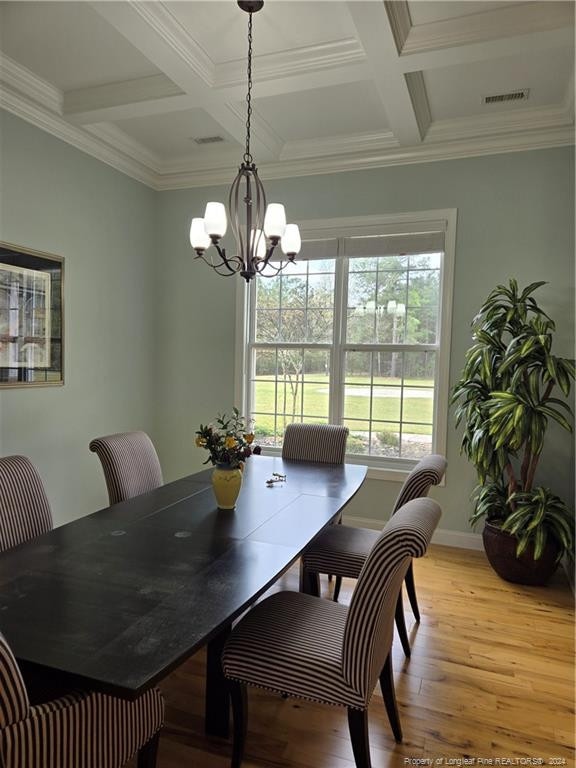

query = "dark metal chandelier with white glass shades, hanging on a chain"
[190,0,301,283]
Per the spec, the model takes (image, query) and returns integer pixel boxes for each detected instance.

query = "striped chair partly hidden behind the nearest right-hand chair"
[302,454,446,657]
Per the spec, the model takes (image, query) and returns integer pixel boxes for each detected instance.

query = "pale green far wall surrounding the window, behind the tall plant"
[158,148,574,532]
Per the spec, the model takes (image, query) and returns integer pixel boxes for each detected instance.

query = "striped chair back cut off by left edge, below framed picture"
[0,456,53,552]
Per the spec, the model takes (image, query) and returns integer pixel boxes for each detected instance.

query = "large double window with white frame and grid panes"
[238,211,456,467]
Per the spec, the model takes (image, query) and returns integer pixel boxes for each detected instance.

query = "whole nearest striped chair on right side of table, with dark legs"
[222,499,440,768]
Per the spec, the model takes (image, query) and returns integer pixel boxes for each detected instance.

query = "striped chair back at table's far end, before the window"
[282,424,349,464]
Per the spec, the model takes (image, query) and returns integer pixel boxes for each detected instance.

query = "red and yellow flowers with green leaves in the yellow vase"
[196,407,262,469]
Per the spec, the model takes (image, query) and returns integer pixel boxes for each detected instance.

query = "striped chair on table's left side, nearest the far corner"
[89,432,164,505]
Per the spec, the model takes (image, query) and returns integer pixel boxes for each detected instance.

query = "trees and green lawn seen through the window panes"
[248,246,442,458]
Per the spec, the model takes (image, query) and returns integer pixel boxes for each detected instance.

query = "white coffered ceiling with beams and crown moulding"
[0,0,574,189]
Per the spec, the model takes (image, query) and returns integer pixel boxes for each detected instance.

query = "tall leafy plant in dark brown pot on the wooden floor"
[451,280,575,584]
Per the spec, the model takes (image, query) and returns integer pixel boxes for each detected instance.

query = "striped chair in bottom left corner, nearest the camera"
[0,634,164,768]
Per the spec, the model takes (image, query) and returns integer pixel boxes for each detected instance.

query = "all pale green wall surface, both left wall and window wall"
[0,112,574,532]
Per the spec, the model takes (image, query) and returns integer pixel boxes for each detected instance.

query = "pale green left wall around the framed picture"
[0,112,159,524]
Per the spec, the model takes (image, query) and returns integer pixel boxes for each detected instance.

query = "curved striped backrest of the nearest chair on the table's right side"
[342,498,441,705]
